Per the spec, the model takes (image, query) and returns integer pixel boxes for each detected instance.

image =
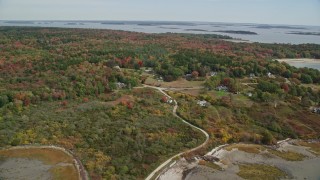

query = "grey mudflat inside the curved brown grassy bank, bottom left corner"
[0,158,52,180]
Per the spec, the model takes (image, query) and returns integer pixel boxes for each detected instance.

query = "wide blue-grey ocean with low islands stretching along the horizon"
[0,21,320,44]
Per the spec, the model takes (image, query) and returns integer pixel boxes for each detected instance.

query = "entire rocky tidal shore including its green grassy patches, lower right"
[159,140,320,180]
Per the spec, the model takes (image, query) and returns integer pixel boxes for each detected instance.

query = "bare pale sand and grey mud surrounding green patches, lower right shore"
[159,140,320,180]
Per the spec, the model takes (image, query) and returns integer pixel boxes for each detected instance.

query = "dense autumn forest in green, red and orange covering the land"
[0,27,320,179]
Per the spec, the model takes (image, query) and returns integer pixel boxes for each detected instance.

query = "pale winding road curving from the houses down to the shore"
[143,85,209,180]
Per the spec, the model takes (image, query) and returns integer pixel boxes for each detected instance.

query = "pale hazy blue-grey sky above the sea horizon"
[0,0,320,26]
